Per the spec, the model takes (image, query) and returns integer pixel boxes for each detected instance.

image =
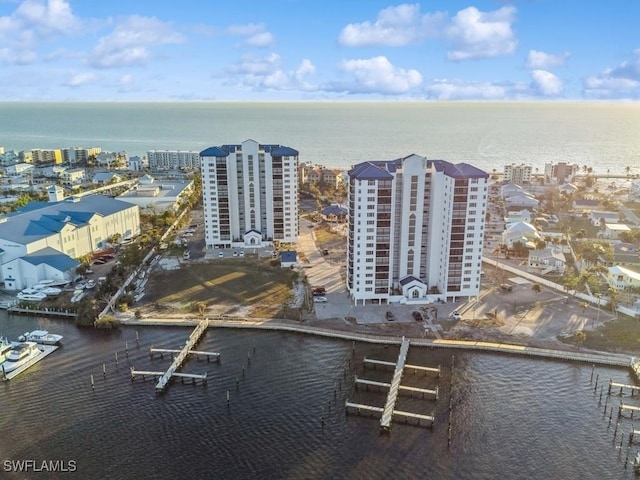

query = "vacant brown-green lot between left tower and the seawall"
[144,256,297,318]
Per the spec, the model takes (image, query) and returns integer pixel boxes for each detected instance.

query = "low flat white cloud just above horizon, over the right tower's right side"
[424,79,530,100]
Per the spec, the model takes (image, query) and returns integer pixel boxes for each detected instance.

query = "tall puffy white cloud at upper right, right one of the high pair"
[445,6,518,61]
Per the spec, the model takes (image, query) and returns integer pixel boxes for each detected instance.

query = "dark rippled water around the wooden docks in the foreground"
[0,315,640,480]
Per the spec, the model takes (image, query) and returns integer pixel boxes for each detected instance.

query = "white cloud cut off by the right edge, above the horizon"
[583,49,640,99]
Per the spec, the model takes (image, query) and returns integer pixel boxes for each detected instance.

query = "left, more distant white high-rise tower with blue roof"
[200,140,298,249]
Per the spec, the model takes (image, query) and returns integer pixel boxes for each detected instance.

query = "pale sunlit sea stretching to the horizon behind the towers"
[0,102,640,174]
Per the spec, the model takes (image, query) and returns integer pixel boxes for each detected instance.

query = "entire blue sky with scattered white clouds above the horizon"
[0,0,640,101]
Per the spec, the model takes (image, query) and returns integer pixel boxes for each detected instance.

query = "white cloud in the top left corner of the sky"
[0,0,81,64]
